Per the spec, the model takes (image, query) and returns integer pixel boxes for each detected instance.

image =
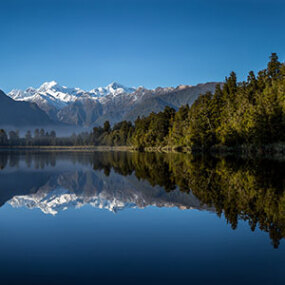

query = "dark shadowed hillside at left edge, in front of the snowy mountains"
[0,90,55,126]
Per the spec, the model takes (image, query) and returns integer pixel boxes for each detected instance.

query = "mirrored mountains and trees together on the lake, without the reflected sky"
[0,151,285,247]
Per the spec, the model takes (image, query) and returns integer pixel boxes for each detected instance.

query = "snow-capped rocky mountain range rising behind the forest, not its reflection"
[8,81,217,126]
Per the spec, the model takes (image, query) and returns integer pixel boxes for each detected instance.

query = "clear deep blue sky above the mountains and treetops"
[0,0,285,92]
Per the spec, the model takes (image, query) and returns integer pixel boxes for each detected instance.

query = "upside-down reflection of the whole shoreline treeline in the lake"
[0,151,285,248]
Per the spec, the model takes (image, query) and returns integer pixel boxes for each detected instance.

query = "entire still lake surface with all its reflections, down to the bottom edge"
[0,152,285,284]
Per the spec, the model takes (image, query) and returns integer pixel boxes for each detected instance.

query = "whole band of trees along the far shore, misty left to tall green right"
[0,53,285,150]
